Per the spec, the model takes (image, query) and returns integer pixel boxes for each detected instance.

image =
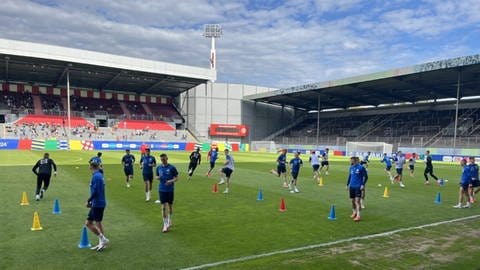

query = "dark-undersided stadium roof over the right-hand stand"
[245,54,480,110]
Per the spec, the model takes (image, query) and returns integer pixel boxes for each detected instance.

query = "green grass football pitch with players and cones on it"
[0,151,480,269]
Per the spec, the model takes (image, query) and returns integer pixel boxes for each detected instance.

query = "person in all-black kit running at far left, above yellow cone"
[32,153,57,201]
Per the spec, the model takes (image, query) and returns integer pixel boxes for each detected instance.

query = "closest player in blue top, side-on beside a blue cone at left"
[85,162,110,251]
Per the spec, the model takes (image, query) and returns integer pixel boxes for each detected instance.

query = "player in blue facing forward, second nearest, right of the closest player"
[157,154,178,232]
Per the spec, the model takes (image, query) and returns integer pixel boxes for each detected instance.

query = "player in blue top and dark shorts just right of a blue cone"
[347,157,368,221]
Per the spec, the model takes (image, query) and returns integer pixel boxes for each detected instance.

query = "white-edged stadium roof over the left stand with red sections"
[0,39,216,96]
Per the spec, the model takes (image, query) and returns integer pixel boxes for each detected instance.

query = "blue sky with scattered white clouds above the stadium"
[0,0,480,87]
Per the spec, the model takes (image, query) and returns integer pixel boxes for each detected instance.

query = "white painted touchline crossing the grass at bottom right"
[183,215,480,270]
